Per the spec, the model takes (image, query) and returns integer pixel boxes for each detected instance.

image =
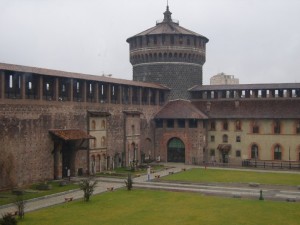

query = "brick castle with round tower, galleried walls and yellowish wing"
[0,7,300,189]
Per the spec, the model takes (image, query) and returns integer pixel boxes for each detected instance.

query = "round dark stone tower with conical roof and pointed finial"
[127,6,208,100]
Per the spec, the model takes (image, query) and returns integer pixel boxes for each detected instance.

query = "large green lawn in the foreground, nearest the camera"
[18,189,300,225]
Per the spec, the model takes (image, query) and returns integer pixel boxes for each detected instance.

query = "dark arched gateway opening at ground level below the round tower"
[168,138,185,163]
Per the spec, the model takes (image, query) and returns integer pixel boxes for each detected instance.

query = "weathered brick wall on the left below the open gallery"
[0,99,160,188]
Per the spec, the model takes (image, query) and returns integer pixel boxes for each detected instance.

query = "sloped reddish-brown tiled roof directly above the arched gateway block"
[155,100,207,119]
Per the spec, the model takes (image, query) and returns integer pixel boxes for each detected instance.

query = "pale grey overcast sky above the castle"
[0,0,300,84]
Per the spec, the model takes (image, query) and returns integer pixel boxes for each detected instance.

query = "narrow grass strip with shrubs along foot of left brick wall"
[0,181,79,205]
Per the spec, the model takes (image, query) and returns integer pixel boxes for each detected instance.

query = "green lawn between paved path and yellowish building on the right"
[161,168,300,186]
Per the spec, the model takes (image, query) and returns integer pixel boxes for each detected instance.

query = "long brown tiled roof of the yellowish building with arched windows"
[192,98,300,119]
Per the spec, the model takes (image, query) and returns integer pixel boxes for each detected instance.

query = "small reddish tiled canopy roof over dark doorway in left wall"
[49,129,94,141]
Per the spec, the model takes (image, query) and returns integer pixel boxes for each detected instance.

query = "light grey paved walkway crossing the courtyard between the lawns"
[0,164,300,216]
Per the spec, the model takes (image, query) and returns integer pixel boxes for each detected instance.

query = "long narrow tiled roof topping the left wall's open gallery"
[0,63,169,90]
